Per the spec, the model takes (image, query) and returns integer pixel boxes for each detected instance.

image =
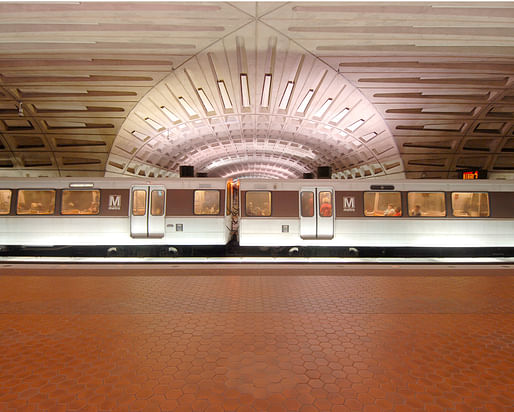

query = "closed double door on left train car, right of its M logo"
[130,185,166,238]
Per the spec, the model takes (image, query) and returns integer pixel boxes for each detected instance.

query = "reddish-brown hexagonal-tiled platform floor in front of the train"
[0,266,514,412]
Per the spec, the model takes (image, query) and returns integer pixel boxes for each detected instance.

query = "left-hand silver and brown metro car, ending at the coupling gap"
[0,178,232,251]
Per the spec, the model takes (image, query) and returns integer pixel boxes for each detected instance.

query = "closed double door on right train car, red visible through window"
[300,187,334,239]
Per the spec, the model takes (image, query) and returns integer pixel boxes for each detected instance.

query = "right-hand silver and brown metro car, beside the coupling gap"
[239,179,514,251]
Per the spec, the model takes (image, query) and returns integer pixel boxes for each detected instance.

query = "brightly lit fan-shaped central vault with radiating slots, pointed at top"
[107,21,396,178]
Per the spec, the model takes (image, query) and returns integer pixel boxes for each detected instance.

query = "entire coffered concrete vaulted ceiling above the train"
[0,2,514,178]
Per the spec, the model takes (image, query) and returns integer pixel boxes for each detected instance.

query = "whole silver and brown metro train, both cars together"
[0,178,514,256]
